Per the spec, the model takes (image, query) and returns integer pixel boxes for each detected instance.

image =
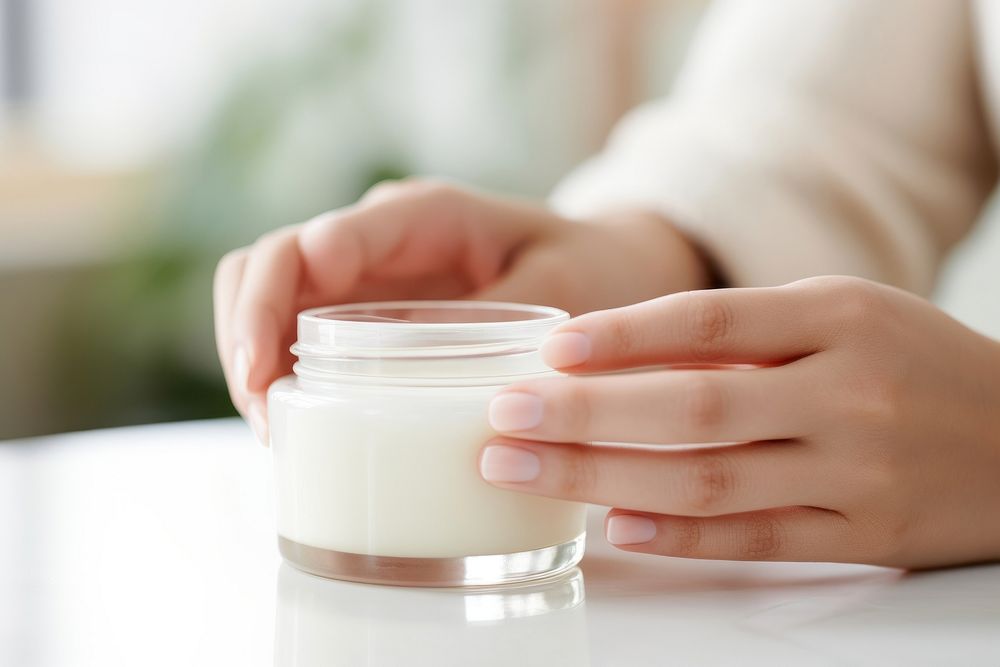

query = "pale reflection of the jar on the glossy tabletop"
[274,563,589,667]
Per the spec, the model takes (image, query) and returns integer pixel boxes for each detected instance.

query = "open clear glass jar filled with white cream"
[268,301,585,586]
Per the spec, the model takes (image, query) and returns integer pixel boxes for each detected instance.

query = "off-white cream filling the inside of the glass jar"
[270,378,584,557]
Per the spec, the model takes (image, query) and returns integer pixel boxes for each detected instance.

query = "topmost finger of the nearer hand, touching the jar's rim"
[542,284,831,372]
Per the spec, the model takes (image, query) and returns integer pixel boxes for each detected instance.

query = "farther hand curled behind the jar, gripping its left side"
[215,180,707,439]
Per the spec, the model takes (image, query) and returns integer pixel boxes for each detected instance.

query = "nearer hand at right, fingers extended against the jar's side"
[480,277,1000,568]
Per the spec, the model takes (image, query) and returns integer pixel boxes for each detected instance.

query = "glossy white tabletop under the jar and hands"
[0,420,1000,667]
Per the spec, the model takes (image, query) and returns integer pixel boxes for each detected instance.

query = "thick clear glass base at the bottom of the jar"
[278,533,586,588]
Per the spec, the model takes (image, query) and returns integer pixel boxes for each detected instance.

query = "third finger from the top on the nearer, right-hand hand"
[479,438,832,516]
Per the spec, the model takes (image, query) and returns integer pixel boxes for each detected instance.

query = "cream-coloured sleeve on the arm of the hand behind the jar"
[551,0,996,293]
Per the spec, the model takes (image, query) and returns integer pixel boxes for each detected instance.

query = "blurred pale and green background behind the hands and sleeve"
[0,0,1000,439]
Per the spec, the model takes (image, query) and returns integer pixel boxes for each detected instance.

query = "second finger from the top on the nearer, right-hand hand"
[489,360,824,444]
